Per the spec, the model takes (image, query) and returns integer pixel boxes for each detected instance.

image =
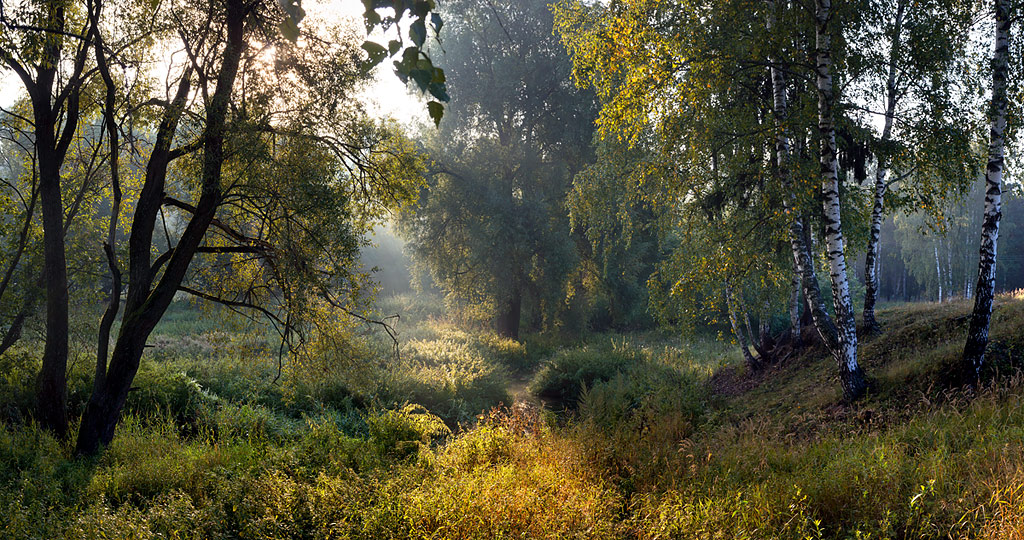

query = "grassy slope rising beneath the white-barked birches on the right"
[626,296,1024,538]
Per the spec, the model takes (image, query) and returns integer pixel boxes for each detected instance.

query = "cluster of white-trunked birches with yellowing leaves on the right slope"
[554,0,1020,400]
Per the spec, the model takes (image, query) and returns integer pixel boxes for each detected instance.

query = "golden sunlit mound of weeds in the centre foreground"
[364,413,622,539]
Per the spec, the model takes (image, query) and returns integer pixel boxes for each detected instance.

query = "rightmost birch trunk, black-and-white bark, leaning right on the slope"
[959,0,1011,384]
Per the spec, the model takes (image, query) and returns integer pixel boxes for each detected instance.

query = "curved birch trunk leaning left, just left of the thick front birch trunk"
[768,1,839,358]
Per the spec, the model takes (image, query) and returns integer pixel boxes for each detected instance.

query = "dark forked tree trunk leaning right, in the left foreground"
[75,0,250,455]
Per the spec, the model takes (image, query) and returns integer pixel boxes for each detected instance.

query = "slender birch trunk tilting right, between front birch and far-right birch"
[864,0,906,333]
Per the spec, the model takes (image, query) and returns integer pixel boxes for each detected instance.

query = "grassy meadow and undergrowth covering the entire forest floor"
[0,294,1024,540]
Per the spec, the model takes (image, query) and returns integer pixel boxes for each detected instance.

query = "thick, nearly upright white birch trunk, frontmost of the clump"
[814,0,866,400]
